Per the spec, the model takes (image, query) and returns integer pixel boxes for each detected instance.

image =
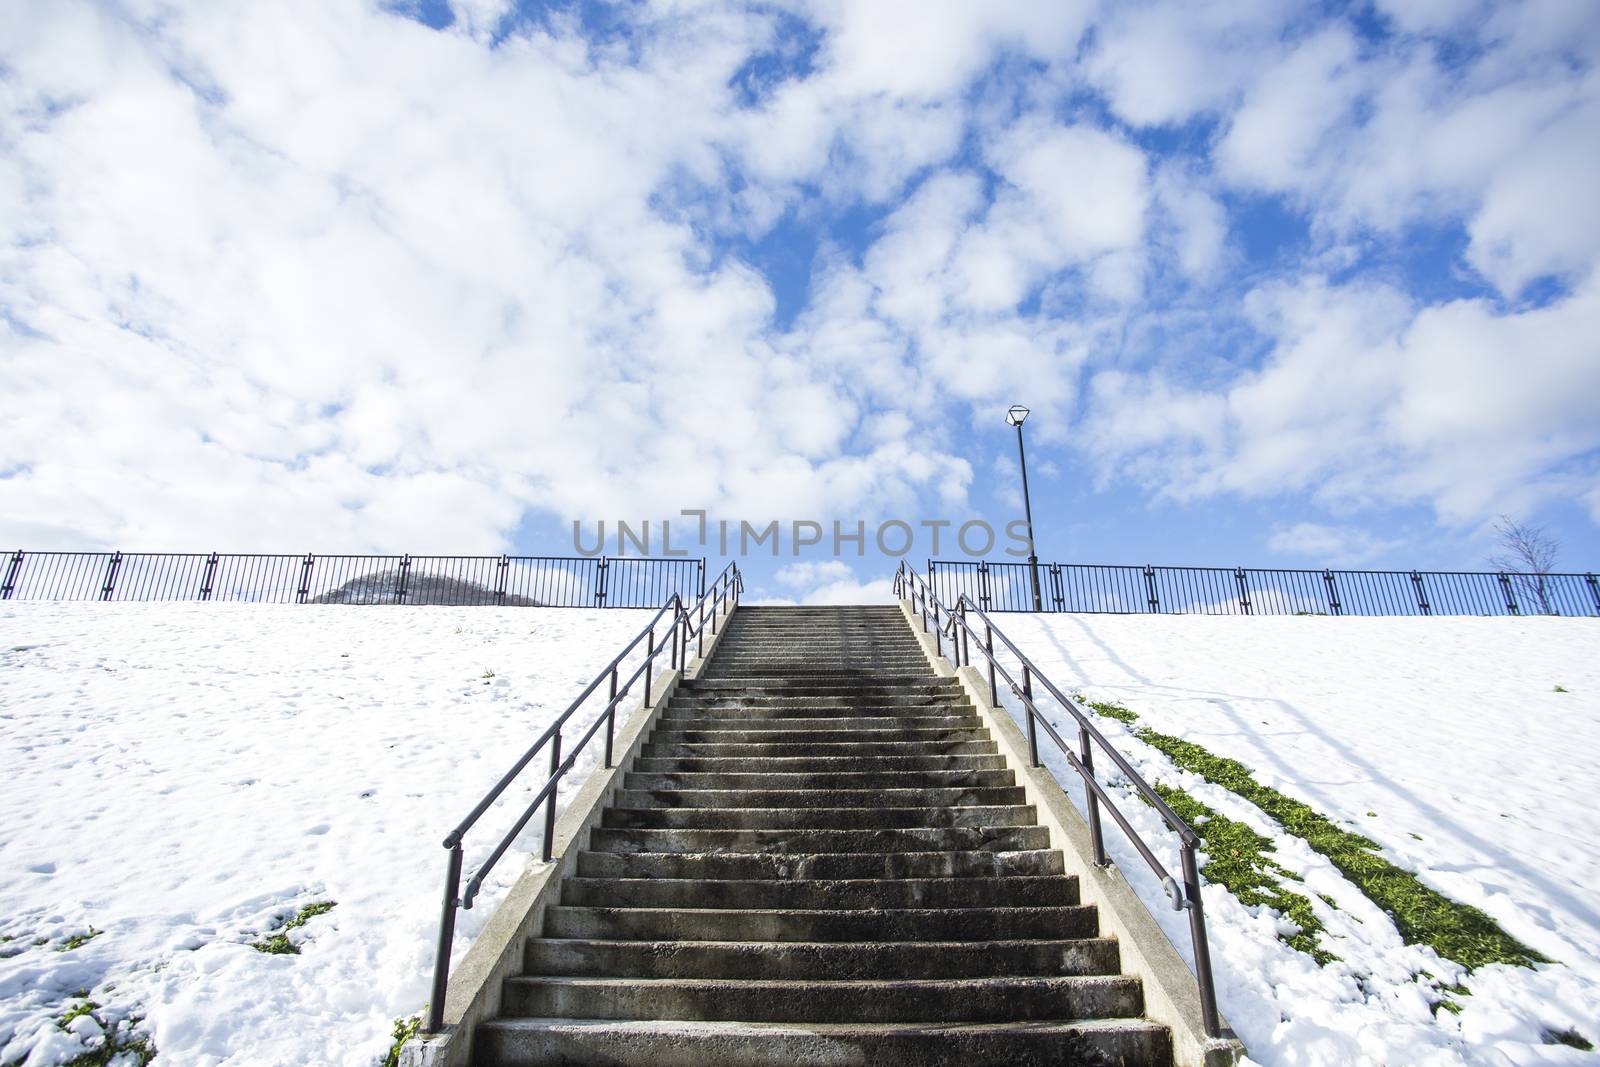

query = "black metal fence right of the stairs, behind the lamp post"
[928,560,1600,616]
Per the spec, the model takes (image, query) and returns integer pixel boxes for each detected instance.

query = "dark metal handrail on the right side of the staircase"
[894,561,1222,1037]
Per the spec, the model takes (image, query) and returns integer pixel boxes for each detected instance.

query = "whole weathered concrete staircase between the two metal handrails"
[474,606,1171,1067]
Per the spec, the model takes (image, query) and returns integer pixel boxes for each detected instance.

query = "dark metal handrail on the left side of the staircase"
[427,563,744,1032]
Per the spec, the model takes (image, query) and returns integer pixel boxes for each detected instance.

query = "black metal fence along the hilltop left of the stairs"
[0,550,706,608]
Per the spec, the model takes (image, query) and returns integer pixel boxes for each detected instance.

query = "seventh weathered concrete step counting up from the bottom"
[589,825,1050,856]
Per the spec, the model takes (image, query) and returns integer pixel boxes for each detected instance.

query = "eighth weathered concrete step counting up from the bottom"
[600,805,1038,830]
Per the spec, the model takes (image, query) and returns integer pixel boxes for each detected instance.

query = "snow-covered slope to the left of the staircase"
[0,603,648,1067]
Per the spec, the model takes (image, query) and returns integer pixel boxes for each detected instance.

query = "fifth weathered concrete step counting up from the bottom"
[562,875,1078,910]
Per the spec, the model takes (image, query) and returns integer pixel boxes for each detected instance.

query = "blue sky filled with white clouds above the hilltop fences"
[0,0,1600,598]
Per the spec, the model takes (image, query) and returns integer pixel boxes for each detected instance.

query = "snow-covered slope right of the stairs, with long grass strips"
[995,614,1600,1065]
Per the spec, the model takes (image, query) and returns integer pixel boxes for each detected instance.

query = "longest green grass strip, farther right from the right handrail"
[1090,702,1549,969]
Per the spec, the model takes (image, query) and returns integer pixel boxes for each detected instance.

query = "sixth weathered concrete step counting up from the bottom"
[578,848,1066,880]
